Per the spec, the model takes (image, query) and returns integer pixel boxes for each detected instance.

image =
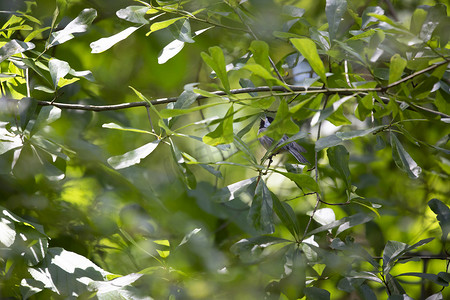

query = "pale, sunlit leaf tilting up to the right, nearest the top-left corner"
[46,8,97,49]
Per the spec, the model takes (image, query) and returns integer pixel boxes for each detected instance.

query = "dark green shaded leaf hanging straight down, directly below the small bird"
[248,180,275,234]
